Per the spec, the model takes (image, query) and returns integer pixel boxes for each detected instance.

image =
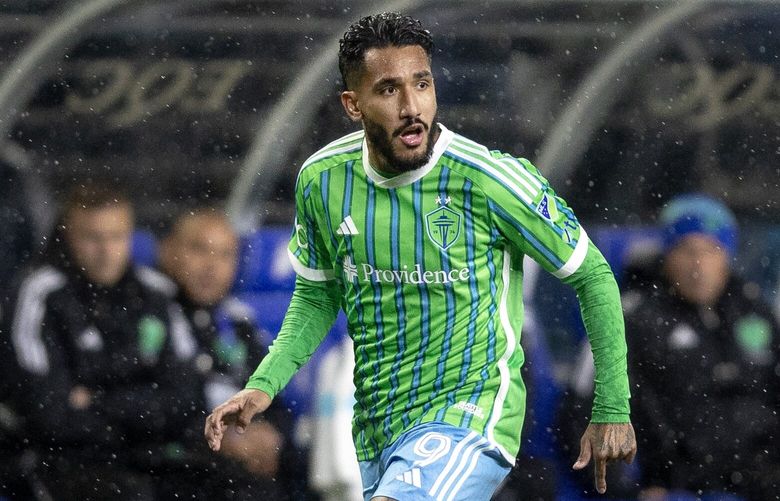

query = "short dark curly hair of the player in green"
[339,12,433,89]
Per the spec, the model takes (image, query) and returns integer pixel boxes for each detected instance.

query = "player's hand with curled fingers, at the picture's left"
[204,389,271,451]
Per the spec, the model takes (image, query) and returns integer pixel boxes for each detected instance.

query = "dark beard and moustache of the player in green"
[363,117,439,173]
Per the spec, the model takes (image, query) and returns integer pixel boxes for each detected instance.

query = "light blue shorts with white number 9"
[360,422,512,501]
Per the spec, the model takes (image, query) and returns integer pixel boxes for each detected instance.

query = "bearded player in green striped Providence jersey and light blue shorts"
[205,13,636,501]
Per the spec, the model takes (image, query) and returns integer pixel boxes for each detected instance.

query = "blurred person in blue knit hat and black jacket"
[560,195,780,500]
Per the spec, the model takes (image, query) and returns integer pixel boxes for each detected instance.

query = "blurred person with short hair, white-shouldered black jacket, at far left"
[3,183,197,500]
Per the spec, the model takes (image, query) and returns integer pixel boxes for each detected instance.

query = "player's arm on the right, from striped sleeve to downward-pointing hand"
[489,157,636,492]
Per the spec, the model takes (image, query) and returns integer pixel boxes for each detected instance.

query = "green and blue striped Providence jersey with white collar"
[272,126,628,461]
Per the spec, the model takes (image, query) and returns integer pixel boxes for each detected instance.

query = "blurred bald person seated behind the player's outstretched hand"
[160,208,301,499]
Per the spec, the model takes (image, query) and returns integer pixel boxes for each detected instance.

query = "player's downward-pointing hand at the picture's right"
[572,423,636,494]
